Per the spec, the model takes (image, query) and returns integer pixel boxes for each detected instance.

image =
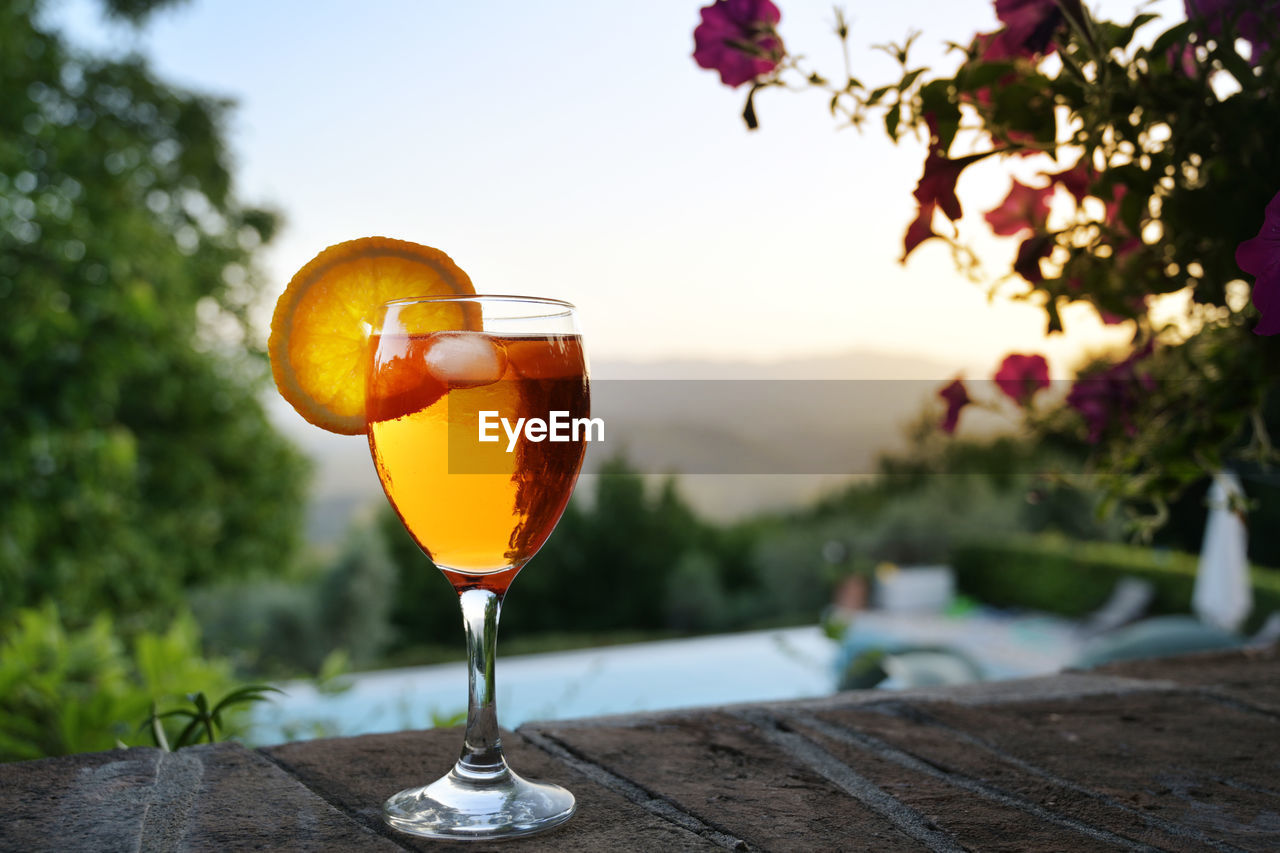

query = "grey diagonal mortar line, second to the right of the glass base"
[730,710,969,853]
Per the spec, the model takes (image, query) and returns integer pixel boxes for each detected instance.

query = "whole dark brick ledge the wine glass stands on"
[0,648,1280,852]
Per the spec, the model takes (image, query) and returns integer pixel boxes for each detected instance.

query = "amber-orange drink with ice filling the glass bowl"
[366,332,590,592]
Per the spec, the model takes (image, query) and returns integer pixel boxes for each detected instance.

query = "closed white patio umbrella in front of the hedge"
[1192,471,1253,631]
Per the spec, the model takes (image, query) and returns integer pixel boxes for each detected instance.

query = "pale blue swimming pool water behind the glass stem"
[250,628,837,743]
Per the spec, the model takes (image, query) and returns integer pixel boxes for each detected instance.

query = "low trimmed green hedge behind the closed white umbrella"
[951,535,1280,630]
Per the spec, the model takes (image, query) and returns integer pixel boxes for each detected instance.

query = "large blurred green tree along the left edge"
[0,0,305,630]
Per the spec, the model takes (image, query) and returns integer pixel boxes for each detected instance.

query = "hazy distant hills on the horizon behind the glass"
[268,351,956,537]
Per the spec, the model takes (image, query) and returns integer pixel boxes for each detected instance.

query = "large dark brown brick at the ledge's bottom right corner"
[798,693,1280,850]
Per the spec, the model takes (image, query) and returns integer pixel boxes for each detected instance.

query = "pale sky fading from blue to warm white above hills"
[51,0,1180,375]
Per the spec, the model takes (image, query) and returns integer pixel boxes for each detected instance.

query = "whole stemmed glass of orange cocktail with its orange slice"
[269,237,591,839]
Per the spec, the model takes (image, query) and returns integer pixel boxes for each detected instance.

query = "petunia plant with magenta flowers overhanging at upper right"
[694,0,1280,535]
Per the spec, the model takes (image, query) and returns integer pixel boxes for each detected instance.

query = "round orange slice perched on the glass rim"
[268,237,477,435]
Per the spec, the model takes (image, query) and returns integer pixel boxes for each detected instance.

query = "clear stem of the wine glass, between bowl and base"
[454,589,509,781]
